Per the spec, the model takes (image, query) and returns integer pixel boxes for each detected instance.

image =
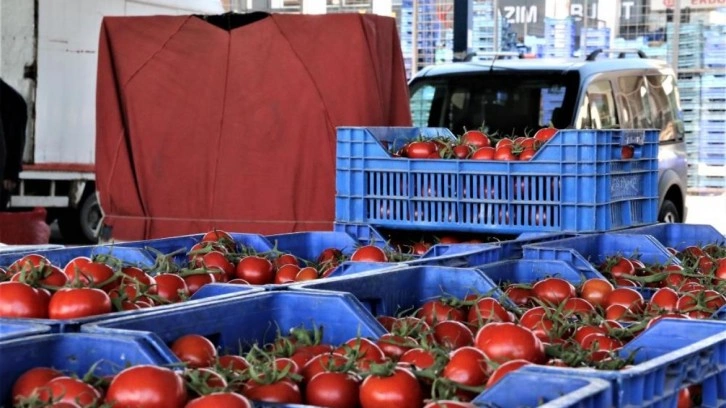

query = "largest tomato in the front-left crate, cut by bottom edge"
[105,365,187,408]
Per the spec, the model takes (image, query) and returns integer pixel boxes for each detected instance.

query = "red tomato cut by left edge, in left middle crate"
[0,281,49,319]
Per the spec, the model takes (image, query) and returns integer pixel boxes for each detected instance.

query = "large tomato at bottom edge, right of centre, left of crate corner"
[359,367,423,408]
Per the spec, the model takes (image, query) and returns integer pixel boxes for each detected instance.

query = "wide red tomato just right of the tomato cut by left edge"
[48,288,112,319]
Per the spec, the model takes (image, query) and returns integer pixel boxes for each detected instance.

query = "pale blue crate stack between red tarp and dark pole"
[399,0,442,74]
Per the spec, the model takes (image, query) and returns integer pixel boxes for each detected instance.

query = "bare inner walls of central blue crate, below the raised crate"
[292,266,502,316]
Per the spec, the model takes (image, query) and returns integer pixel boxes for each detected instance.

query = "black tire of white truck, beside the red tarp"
[58,192,101,244]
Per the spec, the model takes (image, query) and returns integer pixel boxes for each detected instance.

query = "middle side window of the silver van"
[618,75,655,129]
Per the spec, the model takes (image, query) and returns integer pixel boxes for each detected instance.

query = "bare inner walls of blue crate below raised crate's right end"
[523,231,679,276]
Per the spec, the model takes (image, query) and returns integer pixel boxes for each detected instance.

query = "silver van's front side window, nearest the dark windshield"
[575,81,620,129]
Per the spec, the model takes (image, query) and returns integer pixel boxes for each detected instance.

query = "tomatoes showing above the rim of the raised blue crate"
[393,127,557,161]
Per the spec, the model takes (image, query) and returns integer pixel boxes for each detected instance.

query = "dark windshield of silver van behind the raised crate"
[410,71,579,136]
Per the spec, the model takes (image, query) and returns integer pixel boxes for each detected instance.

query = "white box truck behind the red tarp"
[0,0,229,243]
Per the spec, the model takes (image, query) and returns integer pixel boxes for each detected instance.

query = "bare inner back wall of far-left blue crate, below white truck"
[0,245,154,269]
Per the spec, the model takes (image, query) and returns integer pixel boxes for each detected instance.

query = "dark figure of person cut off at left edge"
[0,78,28,211]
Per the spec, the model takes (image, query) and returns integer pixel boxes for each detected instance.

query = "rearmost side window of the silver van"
[646,75,682,142]
